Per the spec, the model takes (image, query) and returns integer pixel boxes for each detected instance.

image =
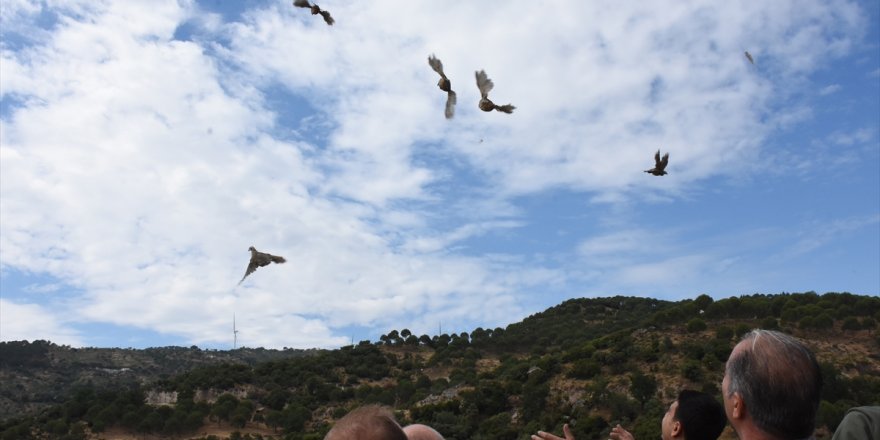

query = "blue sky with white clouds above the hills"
[0,0,880,348]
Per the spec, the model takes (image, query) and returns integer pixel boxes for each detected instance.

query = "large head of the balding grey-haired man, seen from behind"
[721,330,822,439]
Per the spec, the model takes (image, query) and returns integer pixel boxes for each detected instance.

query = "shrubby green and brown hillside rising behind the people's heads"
[0,292,880,439]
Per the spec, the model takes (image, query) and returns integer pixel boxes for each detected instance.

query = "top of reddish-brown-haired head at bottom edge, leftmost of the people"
[324,405,407,440]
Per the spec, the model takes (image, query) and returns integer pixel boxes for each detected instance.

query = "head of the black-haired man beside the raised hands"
[660,390,727,440]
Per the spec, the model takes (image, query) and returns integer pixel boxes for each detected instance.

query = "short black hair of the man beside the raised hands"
[673,390,727,440]
